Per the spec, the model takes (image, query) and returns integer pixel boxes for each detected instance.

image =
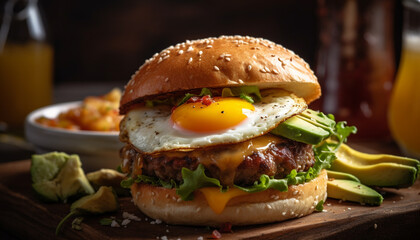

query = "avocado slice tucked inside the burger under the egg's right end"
[271,116,330,145]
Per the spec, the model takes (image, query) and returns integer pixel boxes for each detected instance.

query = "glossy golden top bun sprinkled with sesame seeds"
[120,36,321,114]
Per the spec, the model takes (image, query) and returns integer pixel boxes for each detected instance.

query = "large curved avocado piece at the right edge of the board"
[330,144,419,188]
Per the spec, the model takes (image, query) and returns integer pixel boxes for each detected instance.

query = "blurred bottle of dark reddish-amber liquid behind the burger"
[315,0,395,139]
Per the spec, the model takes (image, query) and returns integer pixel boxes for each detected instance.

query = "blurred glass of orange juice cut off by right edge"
[389,0,420,158]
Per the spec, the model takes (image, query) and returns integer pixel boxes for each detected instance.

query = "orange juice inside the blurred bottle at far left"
[0,42,53,128]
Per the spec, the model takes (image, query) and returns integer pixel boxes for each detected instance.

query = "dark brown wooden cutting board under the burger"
[0,160,420,239]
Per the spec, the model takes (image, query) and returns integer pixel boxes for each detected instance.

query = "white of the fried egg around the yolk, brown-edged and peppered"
[121,89,307,153]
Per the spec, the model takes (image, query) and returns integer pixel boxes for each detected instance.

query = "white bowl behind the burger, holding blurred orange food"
[25,102,123,171]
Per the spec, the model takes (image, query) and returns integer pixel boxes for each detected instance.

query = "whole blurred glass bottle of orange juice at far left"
[0,0,53,130]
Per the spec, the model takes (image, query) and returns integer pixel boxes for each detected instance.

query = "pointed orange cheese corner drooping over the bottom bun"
[198,187,248,214]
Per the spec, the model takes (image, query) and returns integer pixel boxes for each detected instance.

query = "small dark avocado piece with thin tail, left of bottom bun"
[55,186,120,235]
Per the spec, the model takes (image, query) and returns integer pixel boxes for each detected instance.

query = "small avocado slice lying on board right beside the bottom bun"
[327,179,384,206]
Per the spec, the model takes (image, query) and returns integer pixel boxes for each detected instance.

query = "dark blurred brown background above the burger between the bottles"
[40,0,401,85]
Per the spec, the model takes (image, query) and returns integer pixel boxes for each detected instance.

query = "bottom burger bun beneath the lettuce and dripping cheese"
[131,170,328,226]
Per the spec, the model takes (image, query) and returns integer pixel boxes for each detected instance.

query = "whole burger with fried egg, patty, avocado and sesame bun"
[120,36,349,226]
